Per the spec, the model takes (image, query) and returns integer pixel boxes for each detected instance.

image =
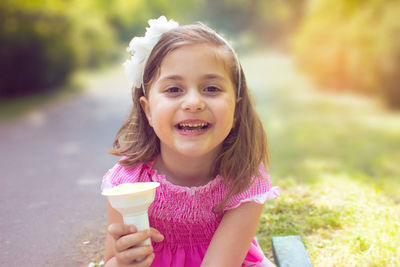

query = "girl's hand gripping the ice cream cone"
[108,223,164,266]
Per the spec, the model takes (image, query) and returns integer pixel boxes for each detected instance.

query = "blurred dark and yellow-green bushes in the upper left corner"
[0,0,113,98]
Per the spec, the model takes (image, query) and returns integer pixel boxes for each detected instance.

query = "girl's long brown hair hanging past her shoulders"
[108,23,269,210]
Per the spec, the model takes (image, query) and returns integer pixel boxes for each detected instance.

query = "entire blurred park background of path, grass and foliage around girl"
[0,0,400,266]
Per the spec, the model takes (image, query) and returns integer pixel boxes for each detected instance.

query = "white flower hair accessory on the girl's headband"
[123,16,179,90]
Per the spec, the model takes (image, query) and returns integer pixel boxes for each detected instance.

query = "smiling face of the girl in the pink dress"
[140,44,236,160]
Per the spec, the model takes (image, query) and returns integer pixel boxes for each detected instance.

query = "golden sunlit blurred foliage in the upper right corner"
[294,0,400,107]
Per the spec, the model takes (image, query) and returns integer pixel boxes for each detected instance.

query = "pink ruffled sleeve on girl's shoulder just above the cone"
[101,158,153,190]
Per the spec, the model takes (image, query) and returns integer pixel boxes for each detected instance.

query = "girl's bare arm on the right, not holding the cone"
[201,202,263,267]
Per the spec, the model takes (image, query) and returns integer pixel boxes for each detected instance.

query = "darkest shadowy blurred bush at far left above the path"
[0,3,75,97]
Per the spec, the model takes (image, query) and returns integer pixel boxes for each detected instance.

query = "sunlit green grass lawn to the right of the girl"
[244,53,400,266]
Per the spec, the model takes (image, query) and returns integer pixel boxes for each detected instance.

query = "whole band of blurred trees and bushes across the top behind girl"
[0,0,400,108]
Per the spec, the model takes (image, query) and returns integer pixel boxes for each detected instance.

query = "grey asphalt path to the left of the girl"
[0,68,131,266]
